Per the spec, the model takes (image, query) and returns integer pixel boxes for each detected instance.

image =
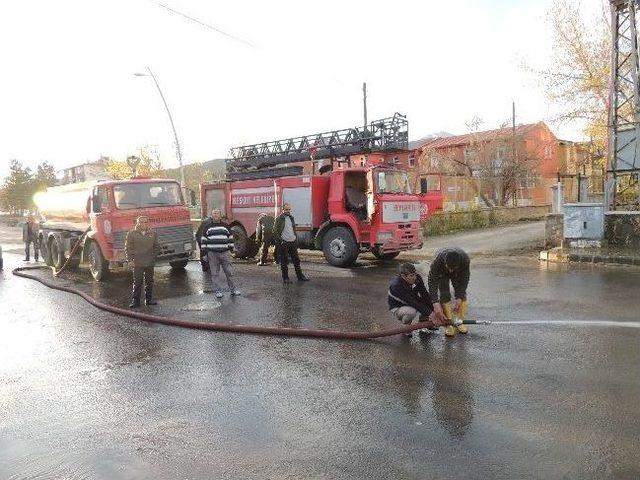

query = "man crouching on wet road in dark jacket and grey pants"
[388,263,449,337]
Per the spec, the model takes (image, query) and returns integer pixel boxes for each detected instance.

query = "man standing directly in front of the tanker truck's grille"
[125,216,160,308]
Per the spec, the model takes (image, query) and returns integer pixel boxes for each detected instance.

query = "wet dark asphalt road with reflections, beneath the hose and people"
[0,238,640,479]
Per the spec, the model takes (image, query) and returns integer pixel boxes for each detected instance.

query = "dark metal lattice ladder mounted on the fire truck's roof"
[226,113,409,174]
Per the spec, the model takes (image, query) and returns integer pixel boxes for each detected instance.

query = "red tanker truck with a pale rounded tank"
[34,177,194,281]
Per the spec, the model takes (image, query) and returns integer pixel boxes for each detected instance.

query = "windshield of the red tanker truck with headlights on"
[113,182,183,210]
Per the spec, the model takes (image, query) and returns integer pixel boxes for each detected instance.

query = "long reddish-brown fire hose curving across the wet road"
[11,231,491,340]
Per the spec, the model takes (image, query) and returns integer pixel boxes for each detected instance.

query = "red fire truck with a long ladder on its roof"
[200,114,438,267]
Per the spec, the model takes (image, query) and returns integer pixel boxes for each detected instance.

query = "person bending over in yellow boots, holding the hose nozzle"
[428,247,471,337]
